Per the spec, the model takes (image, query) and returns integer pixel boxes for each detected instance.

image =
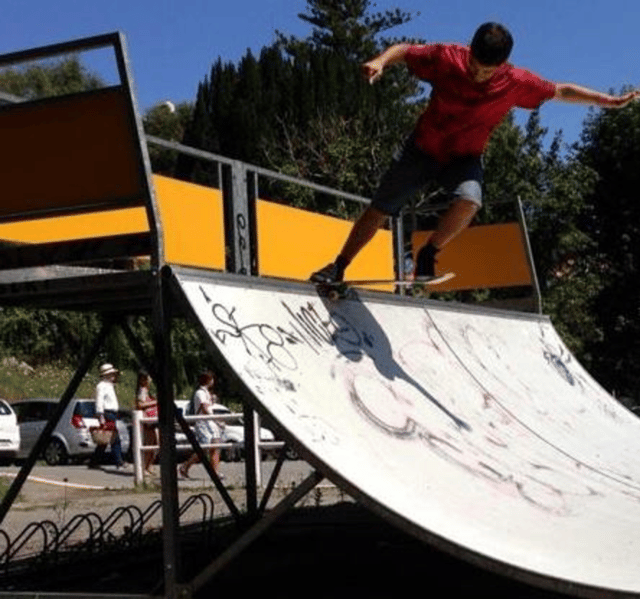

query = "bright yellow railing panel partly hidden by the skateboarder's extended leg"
[256,200,394,290]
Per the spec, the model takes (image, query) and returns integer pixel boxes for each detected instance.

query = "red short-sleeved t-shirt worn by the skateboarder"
[405,44,555,162]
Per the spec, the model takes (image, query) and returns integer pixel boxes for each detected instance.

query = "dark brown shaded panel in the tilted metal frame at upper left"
[0,88,144,218]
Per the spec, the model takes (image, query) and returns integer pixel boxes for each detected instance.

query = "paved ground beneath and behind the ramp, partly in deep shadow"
[0,461,566,599]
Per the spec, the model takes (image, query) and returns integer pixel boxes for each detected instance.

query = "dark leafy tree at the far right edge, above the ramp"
[579,96,640,401]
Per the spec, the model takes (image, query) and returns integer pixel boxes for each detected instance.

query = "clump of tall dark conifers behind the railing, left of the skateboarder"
[179,1,420,214]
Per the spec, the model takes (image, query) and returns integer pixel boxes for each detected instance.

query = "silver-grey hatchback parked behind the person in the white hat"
[13,398,130,466]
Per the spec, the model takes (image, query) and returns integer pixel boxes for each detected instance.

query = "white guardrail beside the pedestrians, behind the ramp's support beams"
[131,410,285,485]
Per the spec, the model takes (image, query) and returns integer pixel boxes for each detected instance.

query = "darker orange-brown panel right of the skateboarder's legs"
[412,223,533,291]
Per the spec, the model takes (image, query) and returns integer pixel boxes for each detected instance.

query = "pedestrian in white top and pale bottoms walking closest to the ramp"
[178,370,223,478]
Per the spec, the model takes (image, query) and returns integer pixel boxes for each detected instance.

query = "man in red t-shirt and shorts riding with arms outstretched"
[311,23,640,283]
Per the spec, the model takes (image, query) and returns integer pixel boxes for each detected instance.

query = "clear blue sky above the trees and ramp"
[0,0,640,151]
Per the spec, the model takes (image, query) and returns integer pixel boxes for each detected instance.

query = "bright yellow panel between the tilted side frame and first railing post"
[153,175,225,270]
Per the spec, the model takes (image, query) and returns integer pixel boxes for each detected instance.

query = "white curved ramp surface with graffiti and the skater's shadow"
[176,271,640,597]
